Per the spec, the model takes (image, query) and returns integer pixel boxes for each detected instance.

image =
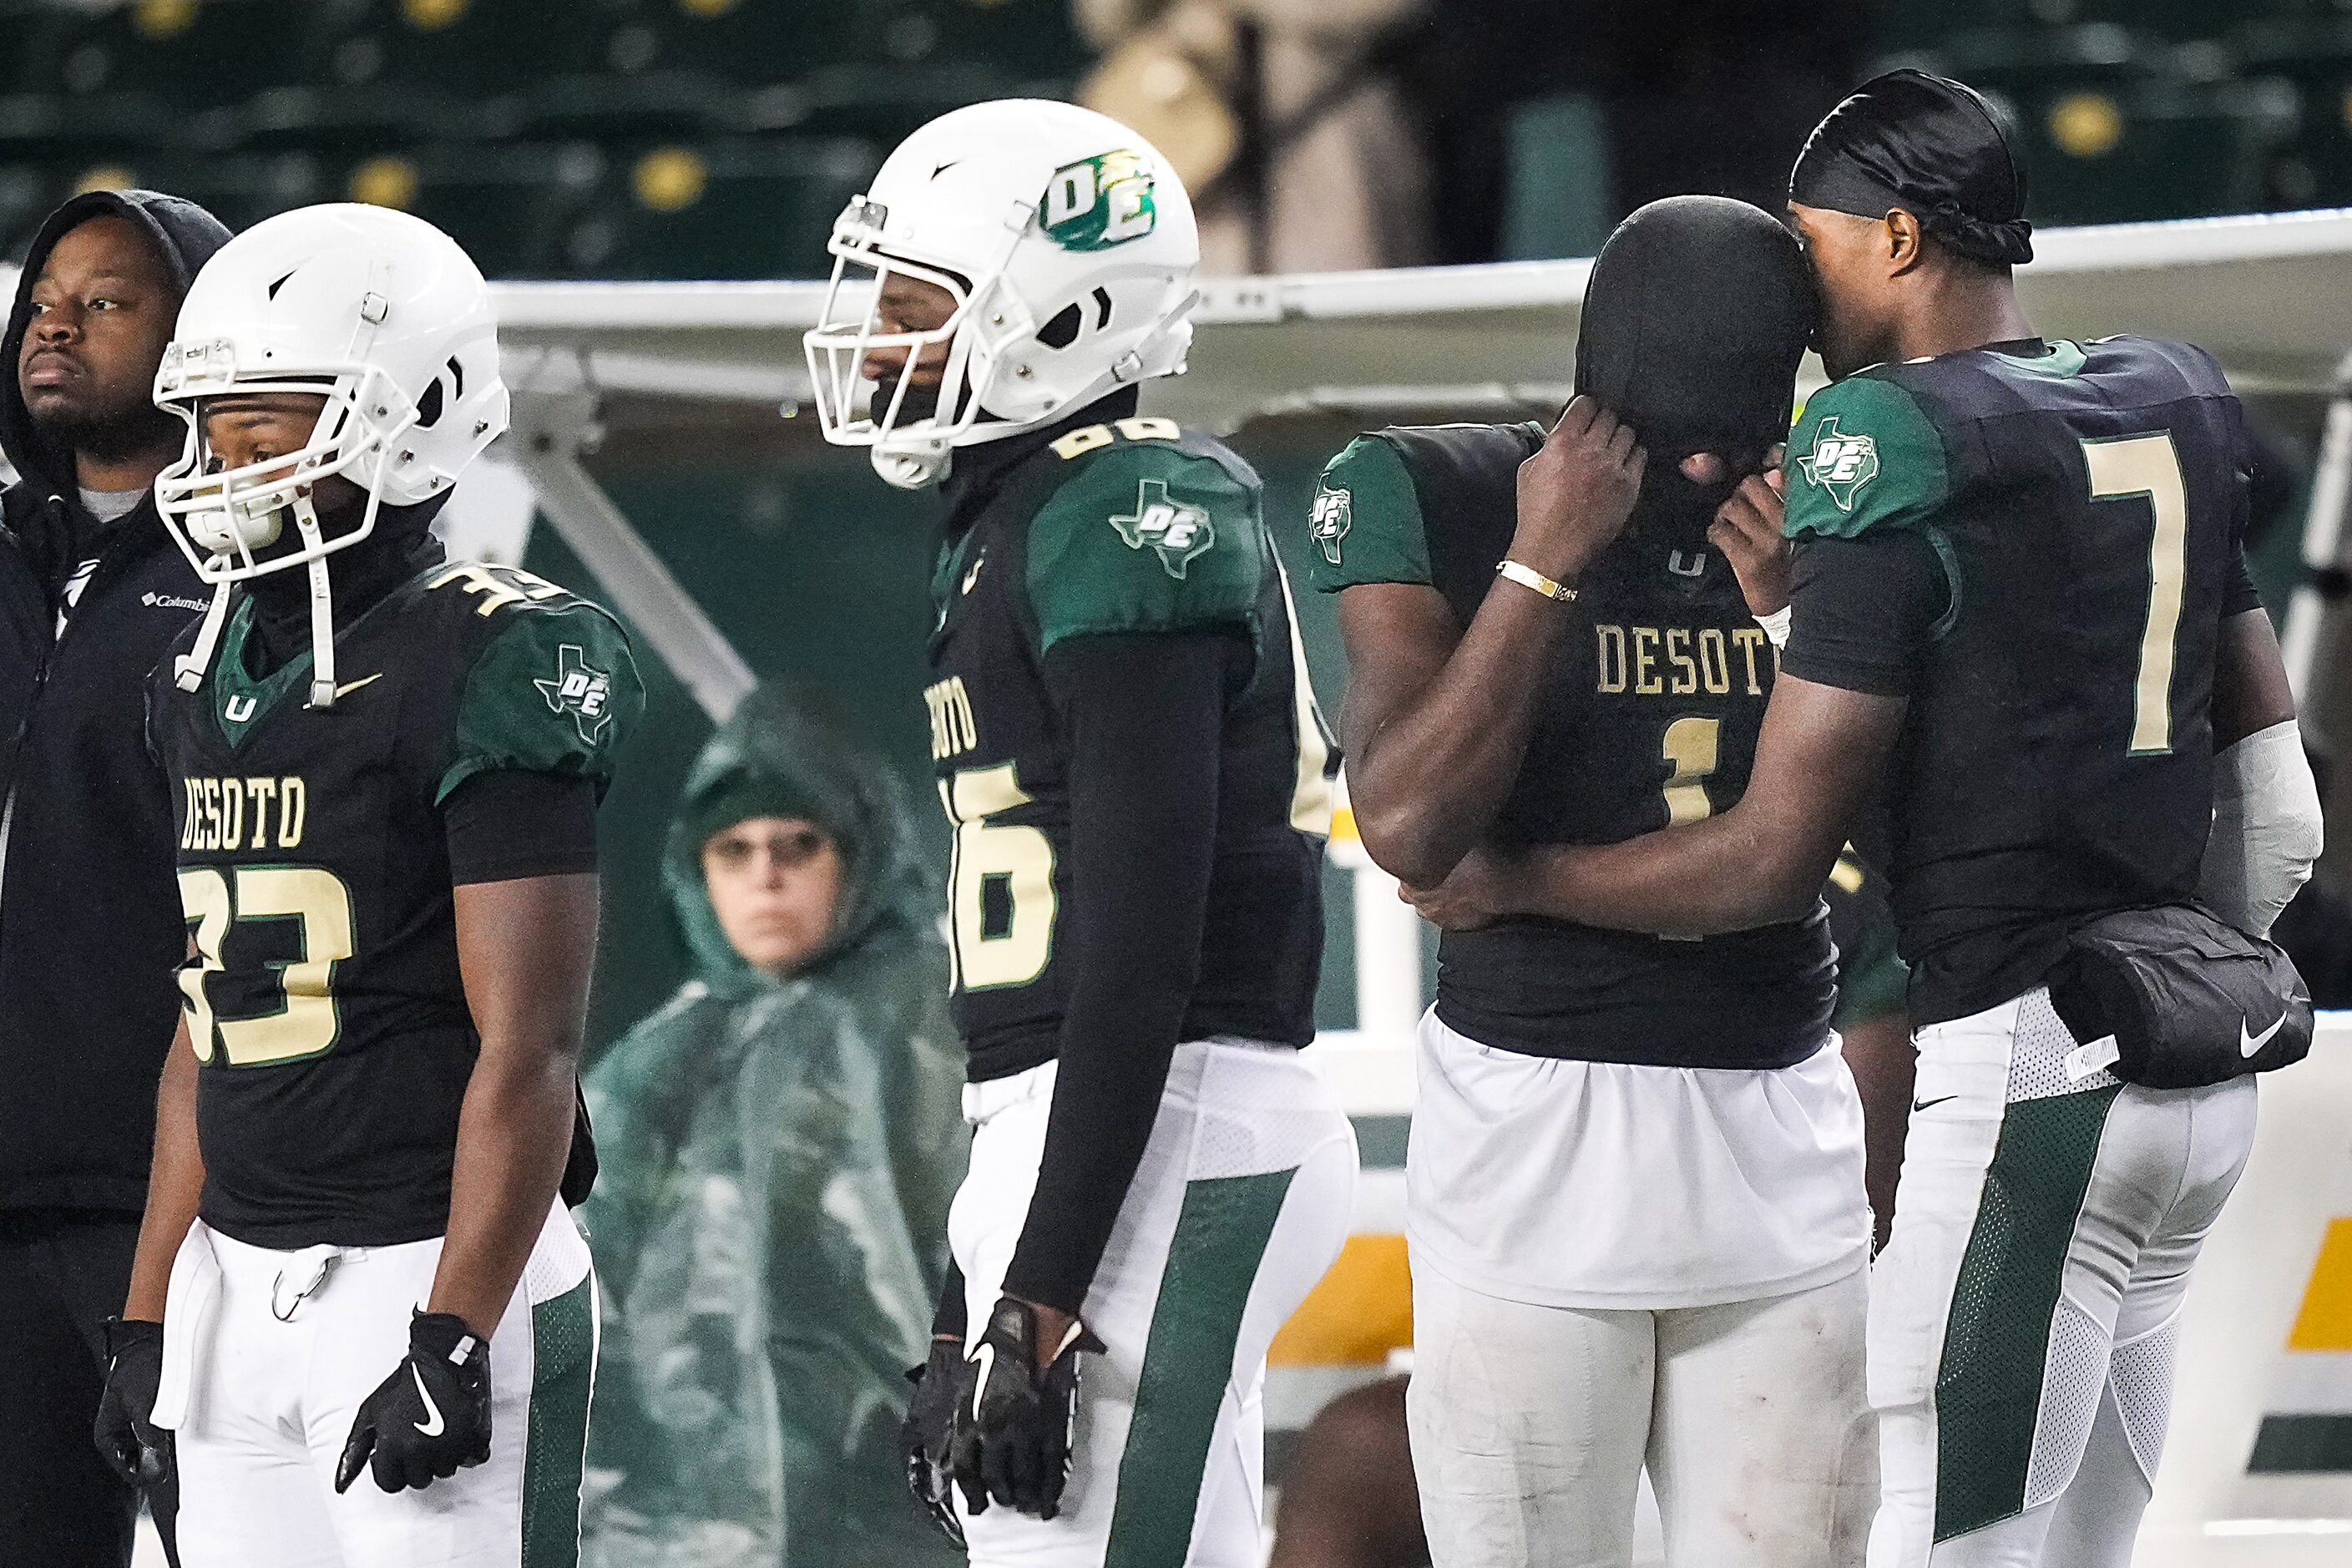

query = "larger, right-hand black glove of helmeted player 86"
[950,1295,1103,1519]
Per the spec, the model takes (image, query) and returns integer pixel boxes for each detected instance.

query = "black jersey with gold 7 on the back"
[1788,338,2256,1023]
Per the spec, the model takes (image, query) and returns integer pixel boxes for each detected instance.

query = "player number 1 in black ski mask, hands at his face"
[1313,195,1874,1568]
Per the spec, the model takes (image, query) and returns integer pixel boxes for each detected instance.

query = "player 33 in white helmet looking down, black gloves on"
[109,205,642,1568]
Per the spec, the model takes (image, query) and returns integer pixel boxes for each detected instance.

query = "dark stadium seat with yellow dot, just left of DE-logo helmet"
[567,139,880,277]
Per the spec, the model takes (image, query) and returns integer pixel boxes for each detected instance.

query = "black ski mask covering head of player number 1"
[1576,195,1813,548]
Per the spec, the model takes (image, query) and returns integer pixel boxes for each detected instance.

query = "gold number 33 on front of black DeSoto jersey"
[179,865,353,1067]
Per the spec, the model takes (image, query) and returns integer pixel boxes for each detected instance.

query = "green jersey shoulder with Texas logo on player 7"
[1785,367,1952,539]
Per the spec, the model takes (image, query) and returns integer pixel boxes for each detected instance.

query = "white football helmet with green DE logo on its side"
[804,99,1200,489]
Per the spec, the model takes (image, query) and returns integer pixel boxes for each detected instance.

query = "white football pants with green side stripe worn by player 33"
[155,1204,598,1568]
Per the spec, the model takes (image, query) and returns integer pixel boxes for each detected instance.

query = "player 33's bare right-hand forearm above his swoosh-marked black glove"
[426,1041,576,1340]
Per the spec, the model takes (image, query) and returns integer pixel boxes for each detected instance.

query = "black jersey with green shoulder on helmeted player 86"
[924,416,1338,1081]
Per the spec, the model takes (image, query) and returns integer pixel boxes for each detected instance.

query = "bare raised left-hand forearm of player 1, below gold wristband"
[1348,579,1576,886]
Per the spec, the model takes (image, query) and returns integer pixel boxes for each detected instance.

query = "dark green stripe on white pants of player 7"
[1935,1086,2119,1540]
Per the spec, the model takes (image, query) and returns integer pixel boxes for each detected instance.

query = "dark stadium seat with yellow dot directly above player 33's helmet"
[325,144,607,277]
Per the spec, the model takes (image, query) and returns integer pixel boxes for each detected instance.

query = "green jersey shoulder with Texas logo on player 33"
[426,562,645,802]
